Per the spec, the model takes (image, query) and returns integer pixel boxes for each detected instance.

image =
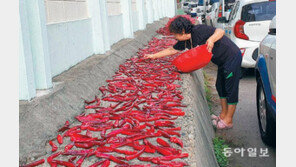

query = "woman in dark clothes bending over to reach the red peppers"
[145,16,242,129]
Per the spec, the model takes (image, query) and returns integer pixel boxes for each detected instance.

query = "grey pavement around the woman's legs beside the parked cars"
[204,63,276,167]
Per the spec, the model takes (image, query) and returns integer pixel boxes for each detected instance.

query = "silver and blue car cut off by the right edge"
[255,17,276,145]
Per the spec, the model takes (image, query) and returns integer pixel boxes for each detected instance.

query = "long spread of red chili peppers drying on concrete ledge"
[24,17,192,167]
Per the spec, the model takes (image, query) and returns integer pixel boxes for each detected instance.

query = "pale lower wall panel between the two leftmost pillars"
[47,19,93,77]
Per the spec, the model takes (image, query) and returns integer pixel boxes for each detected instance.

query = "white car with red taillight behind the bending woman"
[218,0,276,68]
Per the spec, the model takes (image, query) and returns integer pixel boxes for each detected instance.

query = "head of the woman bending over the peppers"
[169,16,193,41]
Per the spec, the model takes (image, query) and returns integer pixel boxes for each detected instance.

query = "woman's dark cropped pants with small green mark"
[216,53,242,105]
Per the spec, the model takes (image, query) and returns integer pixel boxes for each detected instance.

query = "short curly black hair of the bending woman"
[169,16,193,34]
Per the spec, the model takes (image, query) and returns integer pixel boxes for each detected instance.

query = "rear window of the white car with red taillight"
[242,1,276,22]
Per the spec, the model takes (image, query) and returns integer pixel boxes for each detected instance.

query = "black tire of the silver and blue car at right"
[256,78,276,146]
